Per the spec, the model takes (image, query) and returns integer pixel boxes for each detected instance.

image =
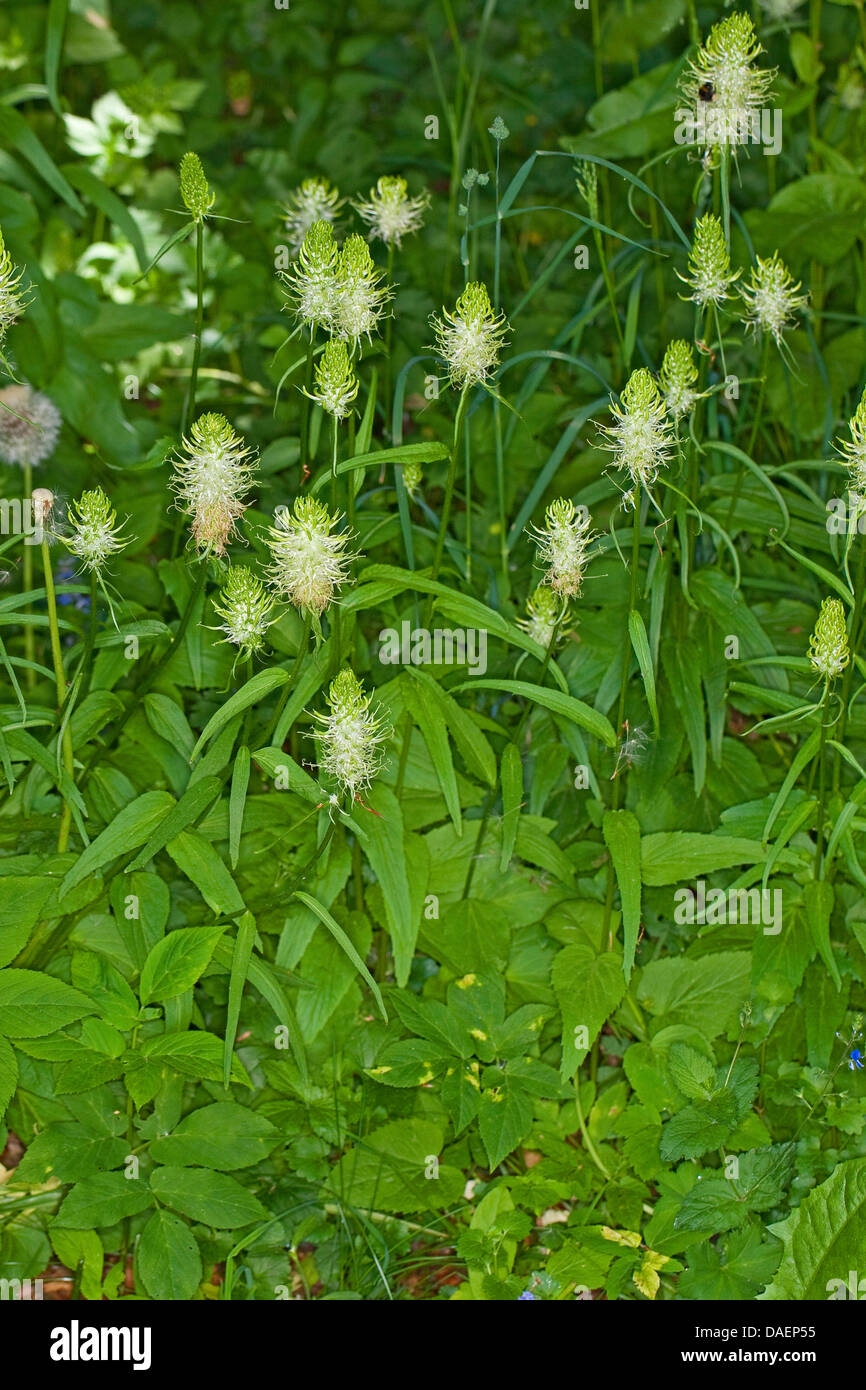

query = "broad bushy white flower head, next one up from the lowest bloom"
[267,498,352,614]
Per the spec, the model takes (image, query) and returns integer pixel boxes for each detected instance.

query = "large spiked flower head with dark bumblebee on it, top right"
[680,13,774,146]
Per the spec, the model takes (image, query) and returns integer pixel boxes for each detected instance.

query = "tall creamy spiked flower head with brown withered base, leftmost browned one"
[172,414,253,555]
